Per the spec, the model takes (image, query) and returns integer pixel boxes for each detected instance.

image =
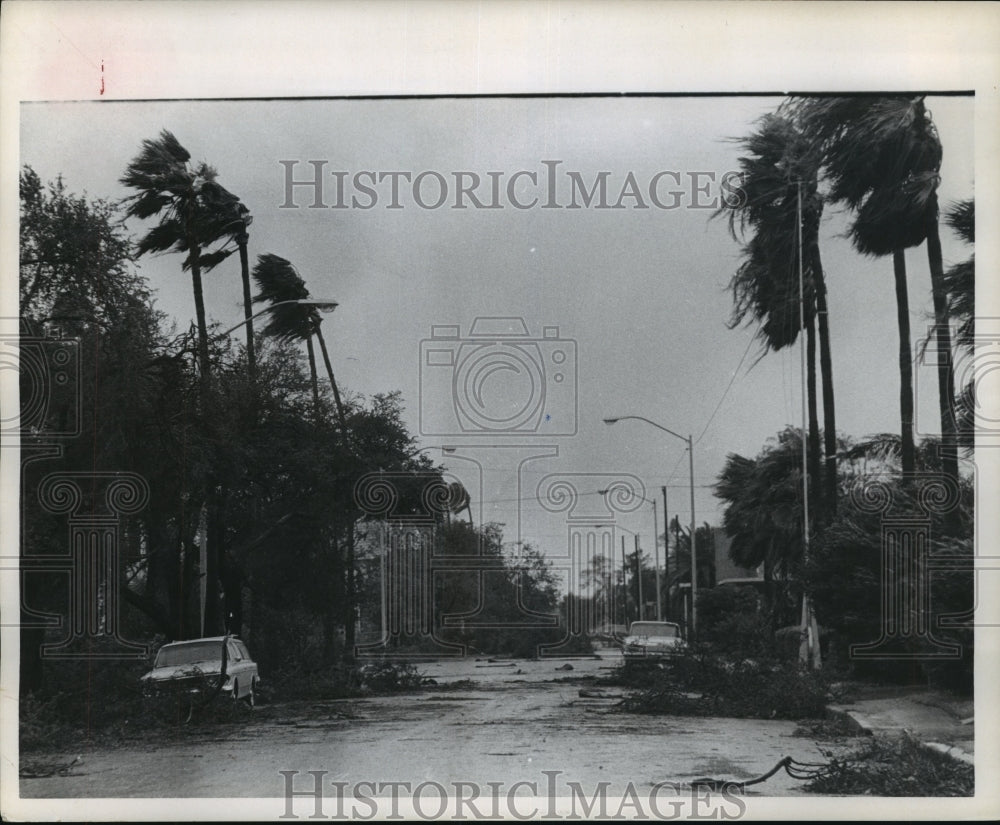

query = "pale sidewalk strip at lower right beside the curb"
[827,688,975,765]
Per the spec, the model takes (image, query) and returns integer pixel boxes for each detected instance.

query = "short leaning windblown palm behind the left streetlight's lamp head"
[253,253,347,438]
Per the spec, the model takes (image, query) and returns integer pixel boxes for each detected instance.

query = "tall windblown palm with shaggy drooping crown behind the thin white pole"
[716,112,837,519]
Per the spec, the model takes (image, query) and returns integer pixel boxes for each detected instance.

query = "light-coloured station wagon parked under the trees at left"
[142,636,260,707]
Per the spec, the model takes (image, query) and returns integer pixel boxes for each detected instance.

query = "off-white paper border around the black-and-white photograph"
[0,0,1000,820]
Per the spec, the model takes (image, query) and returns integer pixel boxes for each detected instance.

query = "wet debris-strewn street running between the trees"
[20,651,824,818]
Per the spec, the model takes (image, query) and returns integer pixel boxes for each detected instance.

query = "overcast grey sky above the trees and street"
[21,97,974,572]
